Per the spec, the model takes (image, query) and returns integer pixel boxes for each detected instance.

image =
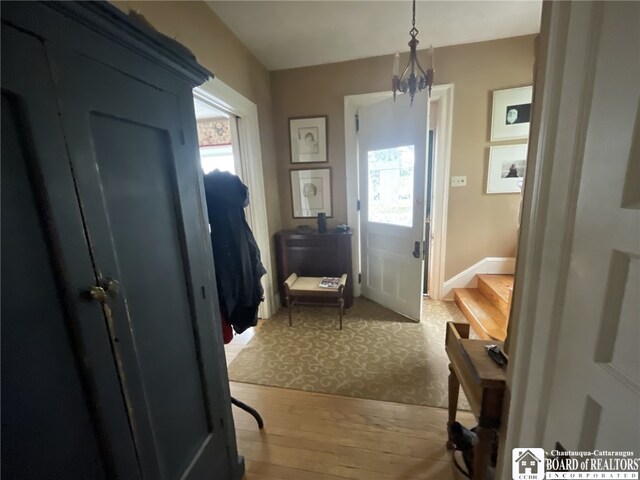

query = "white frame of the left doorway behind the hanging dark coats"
[193,78,275,318]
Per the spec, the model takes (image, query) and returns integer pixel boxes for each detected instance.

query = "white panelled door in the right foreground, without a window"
[544,2,640,451]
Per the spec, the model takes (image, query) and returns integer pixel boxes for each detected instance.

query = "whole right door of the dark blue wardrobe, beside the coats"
[49,46,237,479]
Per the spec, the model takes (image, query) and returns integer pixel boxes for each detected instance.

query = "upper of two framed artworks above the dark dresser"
[289,115,328,163]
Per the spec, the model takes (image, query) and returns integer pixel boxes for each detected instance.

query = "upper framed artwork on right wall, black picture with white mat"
[491,86,533,142]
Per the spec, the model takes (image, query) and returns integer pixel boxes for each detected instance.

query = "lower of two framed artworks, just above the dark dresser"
[290,168,333,218]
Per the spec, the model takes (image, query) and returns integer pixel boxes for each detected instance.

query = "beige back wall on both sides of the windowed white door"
[271,35,534,279]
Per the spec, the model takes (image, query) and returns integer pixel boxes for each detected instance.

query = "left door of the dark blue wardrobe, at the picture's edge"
[1,25,140,480]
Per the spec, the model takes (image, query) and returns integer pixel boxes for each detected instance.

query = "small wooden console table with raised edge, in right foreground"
[445,322,506,480]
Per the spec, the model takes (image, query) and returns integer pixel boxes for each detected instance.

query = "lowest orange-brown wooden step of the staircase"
[453,288,507,342]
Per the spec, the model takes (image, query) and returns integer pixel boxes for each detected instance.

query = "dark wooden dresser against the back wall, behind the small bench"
[275,230,353,308]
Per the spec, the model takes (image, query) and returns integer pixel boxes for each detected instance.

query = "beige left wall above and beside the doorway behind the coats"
[113,1,281,285]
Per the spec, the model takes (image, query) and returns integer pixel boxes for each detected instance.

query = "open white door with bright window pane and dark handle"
[358,92,429,321]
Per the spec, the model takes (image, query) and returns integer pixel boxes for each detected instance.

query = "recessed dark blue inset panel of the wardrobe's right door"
[90,114,208,478]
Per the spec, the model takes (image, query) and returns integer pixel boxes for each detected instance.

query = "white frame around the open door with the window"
[344,84,453,300]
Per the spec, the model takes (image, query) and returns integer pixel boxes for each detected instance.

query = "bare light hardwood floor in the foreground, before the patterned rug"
[231,382,474,480]
